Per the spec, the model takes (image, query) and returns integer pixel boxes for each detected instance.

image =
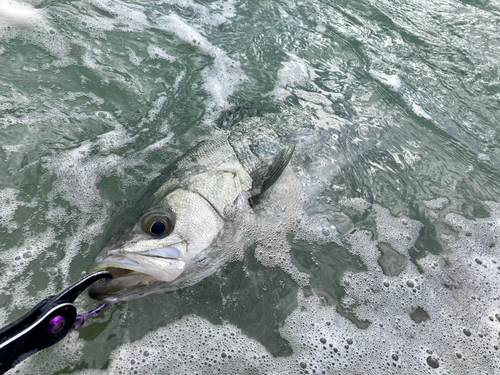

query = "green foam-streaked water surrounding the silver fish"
[0,0,500,374]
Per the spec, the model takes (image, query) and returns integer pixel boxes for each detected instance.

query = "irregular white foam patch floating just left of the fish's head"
[37,116,137,276]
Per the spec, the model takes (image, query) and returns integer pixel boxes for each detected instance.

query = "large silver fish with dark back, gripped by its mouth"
[89,105,295,302]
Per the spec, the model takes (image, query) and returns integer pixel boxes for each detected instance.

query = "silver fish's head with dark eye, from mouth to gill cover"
[89,188,224,302]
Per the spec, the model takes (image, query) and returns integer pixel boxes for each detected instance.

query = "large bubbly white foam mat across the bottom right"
[33,197,500,374]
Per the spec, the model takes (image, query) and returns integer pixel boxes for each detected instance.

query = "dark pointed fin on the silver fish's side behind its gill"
[249,145,295,207]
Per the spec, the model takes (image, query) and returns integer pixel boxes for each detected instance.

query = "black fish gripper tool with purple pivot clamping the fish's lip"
[0,271,112,374]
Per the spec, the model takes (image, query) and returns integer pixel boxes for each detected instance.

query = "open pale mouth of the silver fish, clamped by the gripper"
[89,244,186,301]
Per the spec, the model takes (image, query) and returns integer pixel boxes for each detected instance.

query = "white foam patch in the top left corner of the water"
[0,0,152,70]
